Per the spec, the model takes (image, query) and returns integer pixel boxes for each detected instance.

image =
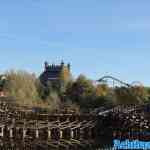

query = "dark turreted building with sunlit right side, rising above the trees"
[40,61,70,88]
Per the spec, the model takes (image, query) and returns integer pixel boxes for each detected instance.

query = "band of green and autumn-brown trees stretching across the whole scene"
[1,71,150,111]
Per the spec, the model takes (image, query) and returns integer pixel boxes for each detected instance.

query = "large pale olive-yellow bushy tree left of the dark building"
[5,70,39,105]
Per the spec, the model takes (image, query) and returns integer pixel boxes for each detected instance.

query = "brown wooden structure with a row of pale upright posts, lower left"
[0,98,96,150]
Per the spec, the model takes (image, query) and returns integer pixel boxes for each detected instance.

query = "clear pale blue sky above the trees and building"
[0,0,150,86]
